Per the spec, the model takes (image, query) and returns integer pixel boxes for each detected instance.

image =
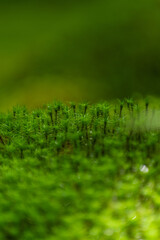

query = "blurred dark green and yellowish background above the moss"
[0,0,160,110]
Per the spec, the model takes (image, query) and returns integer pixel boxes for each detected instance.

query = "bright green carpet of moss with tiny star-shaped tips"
[0,99,160,240]
